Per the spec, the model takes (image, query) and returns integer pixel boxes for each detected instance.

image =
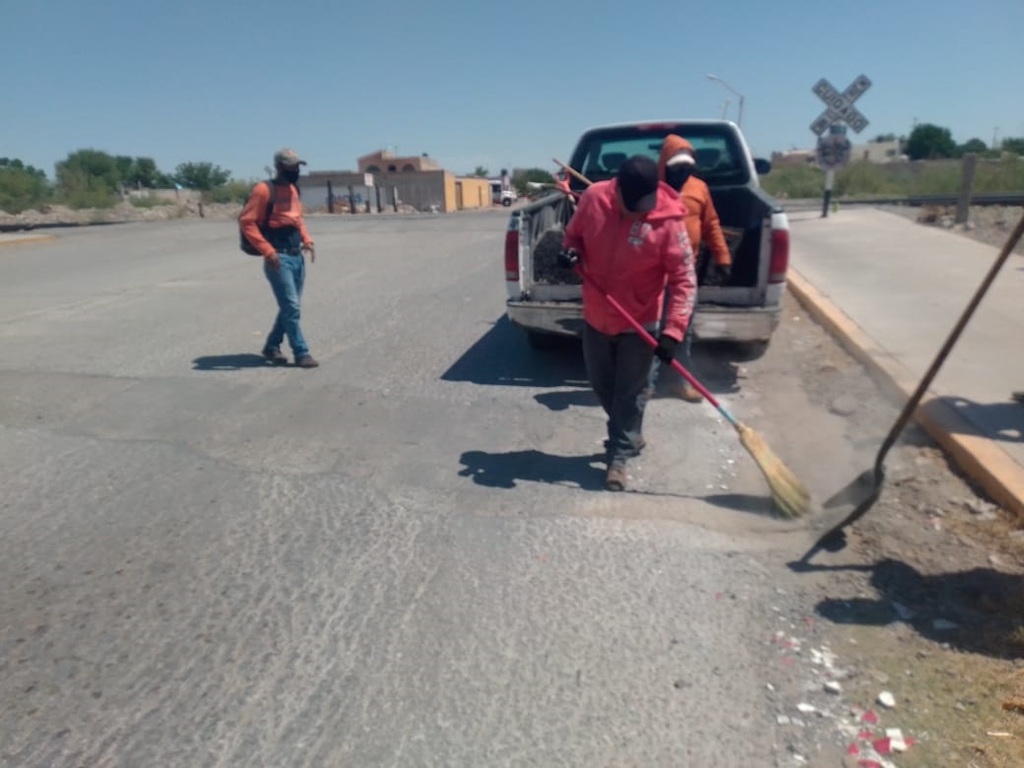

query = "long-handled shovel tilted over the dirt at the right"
[800,210,1024,563]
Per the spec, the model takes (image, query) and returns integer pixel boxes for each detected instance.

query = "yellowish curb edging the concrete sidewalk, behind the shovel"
[787,267,1024,520]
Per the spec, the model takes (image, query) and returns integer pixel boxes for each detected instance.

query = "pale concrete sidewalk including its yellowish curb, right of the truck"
[790,209,1024,520]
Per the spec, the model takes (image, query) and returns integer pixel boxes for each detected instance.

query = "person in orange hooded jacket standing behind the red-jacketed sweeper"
[650,134,732,402]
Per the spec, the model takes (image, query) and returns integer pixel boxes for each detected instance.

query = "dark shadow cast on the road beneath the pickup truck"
[441,315,749,411]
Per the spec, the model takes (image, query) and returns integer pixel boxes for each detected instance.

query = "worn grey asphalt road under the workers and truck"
[0,212,815,766]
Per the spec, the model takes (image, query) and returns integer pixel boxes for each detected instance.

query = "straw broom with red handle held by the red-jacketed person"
[554,159,811,518]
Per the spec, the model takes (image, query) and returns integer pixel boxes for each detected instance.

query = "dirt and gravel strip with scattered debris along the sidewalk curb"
[720,286,1024,768]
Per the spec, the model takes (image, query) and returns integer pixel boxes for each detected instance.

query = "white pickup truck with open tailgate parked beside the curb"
[505,120,790,356]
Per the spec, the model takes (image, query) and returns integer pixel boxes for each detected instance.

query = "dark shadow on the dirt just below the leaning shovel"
[806,559,1024,658]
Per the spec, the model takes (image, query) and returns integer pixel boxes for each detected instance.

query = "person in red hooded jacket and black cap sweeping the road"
[562,156,696,490]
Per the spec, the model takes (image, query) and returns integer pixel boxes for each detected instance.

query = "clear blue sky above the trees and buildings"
[0,0,1024,179]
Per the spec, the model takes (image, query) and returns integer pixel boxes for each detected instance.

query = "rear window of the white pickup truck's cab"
[570,123,750,188]
